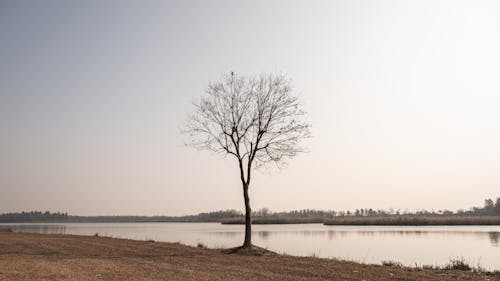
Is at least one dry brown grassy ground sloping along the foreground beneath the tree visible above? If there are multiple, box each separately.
[0,233,500,281]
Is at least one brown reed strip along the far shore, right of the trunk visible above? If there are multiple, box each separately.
[221,216,500,225]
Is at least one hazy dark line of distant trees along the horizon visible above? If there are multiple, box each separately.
[0,198,500,223]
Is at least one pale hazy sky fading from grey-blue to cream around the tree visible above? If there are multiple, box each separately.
[0,0,500,215]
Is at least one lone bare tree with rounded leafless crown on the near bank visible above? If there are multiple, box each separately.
[183,72,310,248]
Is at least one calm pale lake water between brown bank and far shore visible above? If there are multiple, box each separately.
[0,223,500,270]
